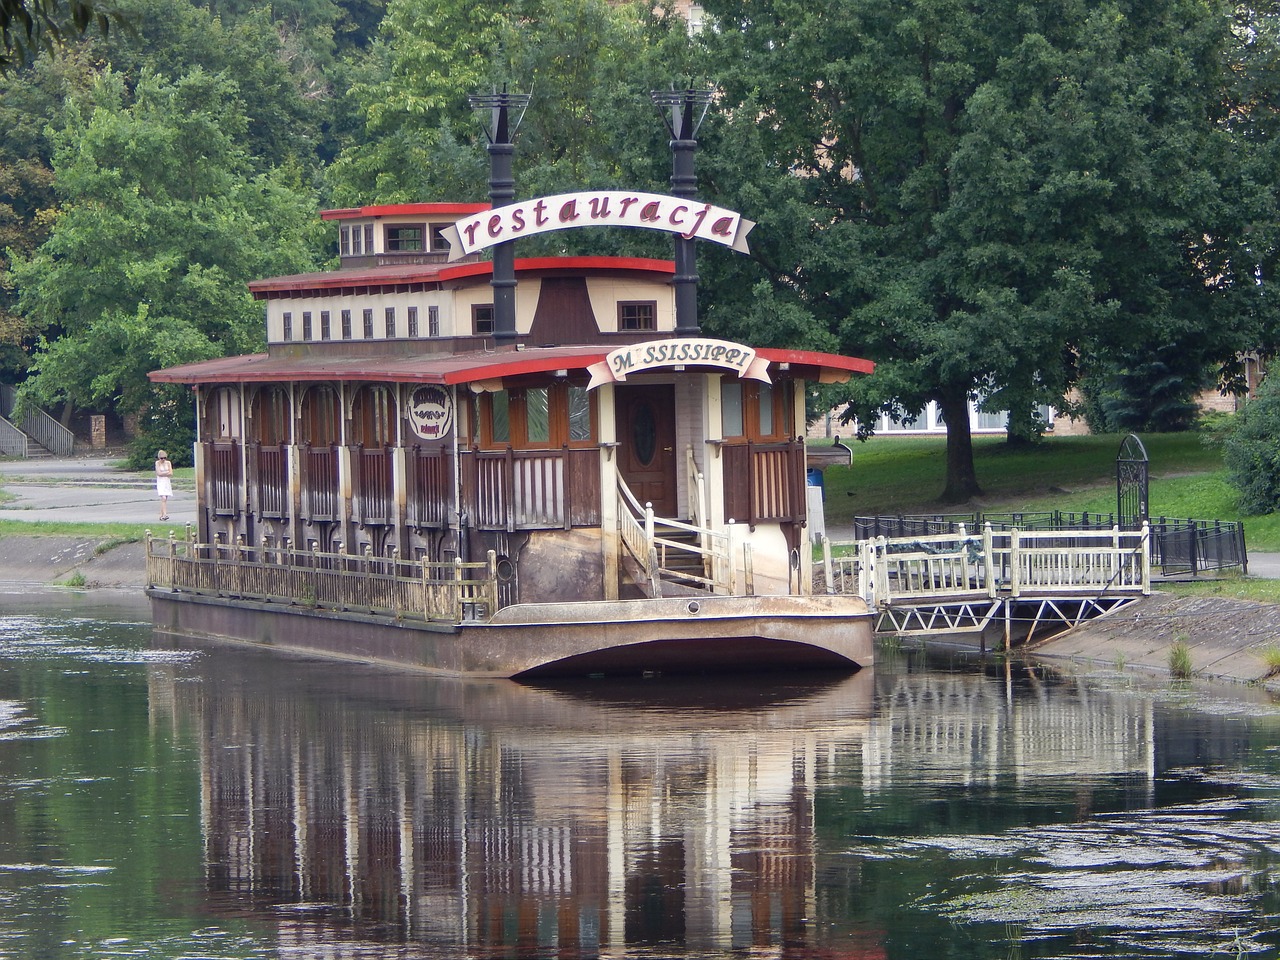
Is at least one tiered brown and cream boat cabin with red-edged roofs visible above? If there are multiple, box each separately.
[152,204,872,604]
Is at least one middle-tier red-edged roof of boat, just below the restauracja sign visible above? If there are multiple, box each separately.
[248,257,676,298]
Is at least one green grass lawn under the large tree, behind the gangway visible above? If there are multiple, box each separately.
[824,433,1280,552]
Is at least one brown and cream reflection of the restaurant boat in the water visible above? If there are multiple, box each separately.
[151,649,883,956]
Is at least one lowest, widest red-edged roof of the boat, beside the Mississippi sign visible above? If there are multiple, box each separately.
[151,344,876,384]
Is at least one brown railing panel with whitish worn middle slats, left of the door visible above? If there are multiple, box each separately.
[463,447,600,531]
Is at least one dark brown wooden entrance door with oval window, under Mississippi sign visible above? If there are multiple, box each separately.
[614,384,678,517]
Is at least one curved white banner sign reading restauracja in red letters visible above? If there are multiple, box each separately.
[444,189,755,262]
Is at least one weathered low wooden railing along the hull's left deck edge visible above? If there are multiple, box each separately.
[146,536,498,623]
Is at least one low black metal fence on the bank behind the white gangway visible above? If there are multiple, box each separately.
[854,511,1249,576]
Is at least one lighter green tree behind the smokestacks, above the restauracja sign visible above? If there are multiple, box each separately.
[330,0,690,216]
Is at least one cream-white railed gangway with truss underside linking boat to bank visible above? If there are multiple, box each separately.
[822,524,1151,646]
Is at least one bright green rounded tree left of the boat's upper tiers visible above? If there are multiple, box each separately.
[13,70,319,435]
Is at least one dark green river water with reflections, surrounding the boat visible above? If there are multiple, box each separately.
[0,593,1280,960]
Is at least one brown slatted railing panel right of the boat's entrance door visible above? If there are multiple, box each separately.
[721,440,806,530]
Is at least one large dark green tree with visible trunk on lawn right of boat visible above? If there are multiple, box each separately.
[700,0,1275,502]
